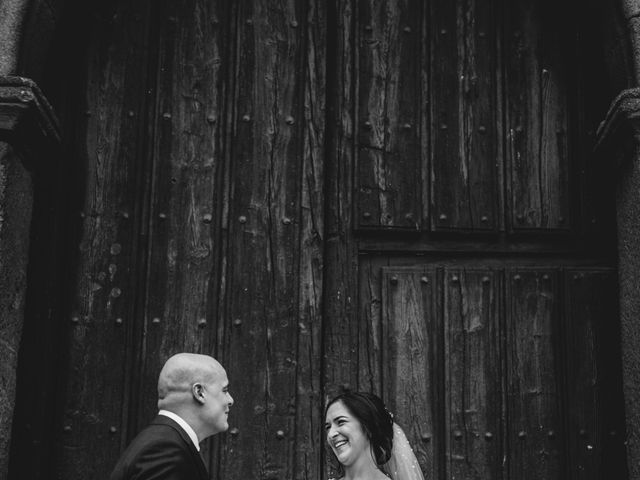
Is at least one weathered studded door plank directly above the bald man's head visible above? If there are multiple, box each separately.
[138,0,228,434]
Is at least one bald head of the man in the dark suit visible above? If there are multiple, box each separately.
[158,353,233,441]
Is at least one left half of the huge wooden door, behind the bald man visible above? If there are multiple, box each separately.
[12,0,327,479]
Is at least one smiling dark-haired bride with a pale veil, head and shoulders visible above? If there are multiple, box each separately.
[325,392,423,480]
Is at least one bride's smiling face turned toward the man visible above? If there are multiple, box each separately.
[325,401,371,467]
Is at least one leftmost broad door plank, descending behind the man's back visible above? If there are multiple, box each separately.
[56,2,148,478]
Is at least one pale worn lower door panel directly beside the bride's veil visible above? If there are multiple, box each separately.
[382,267,443,478]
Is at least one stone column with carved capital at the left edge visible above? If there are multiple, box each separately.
[0,77,60,478]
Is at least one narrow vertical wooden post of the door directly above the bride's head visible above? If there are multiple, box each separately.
[322,0,360,400]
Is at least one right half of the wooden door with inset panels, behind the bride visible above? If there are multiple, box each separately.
[324,0,626,480]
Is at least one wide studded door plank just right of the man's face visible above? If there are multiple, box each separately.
[221,1,304,479]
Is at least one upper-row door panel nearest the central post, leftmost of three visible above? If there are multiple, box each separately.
[356,0,424,230]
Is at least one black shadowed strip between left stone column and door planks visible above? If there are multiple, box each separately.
[9,1,92,480]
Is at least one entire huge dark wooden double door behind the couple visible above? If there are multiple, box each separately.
[6,0,626,480]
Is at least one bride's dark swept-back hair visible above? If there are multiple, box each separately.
[324,391,393,470]
